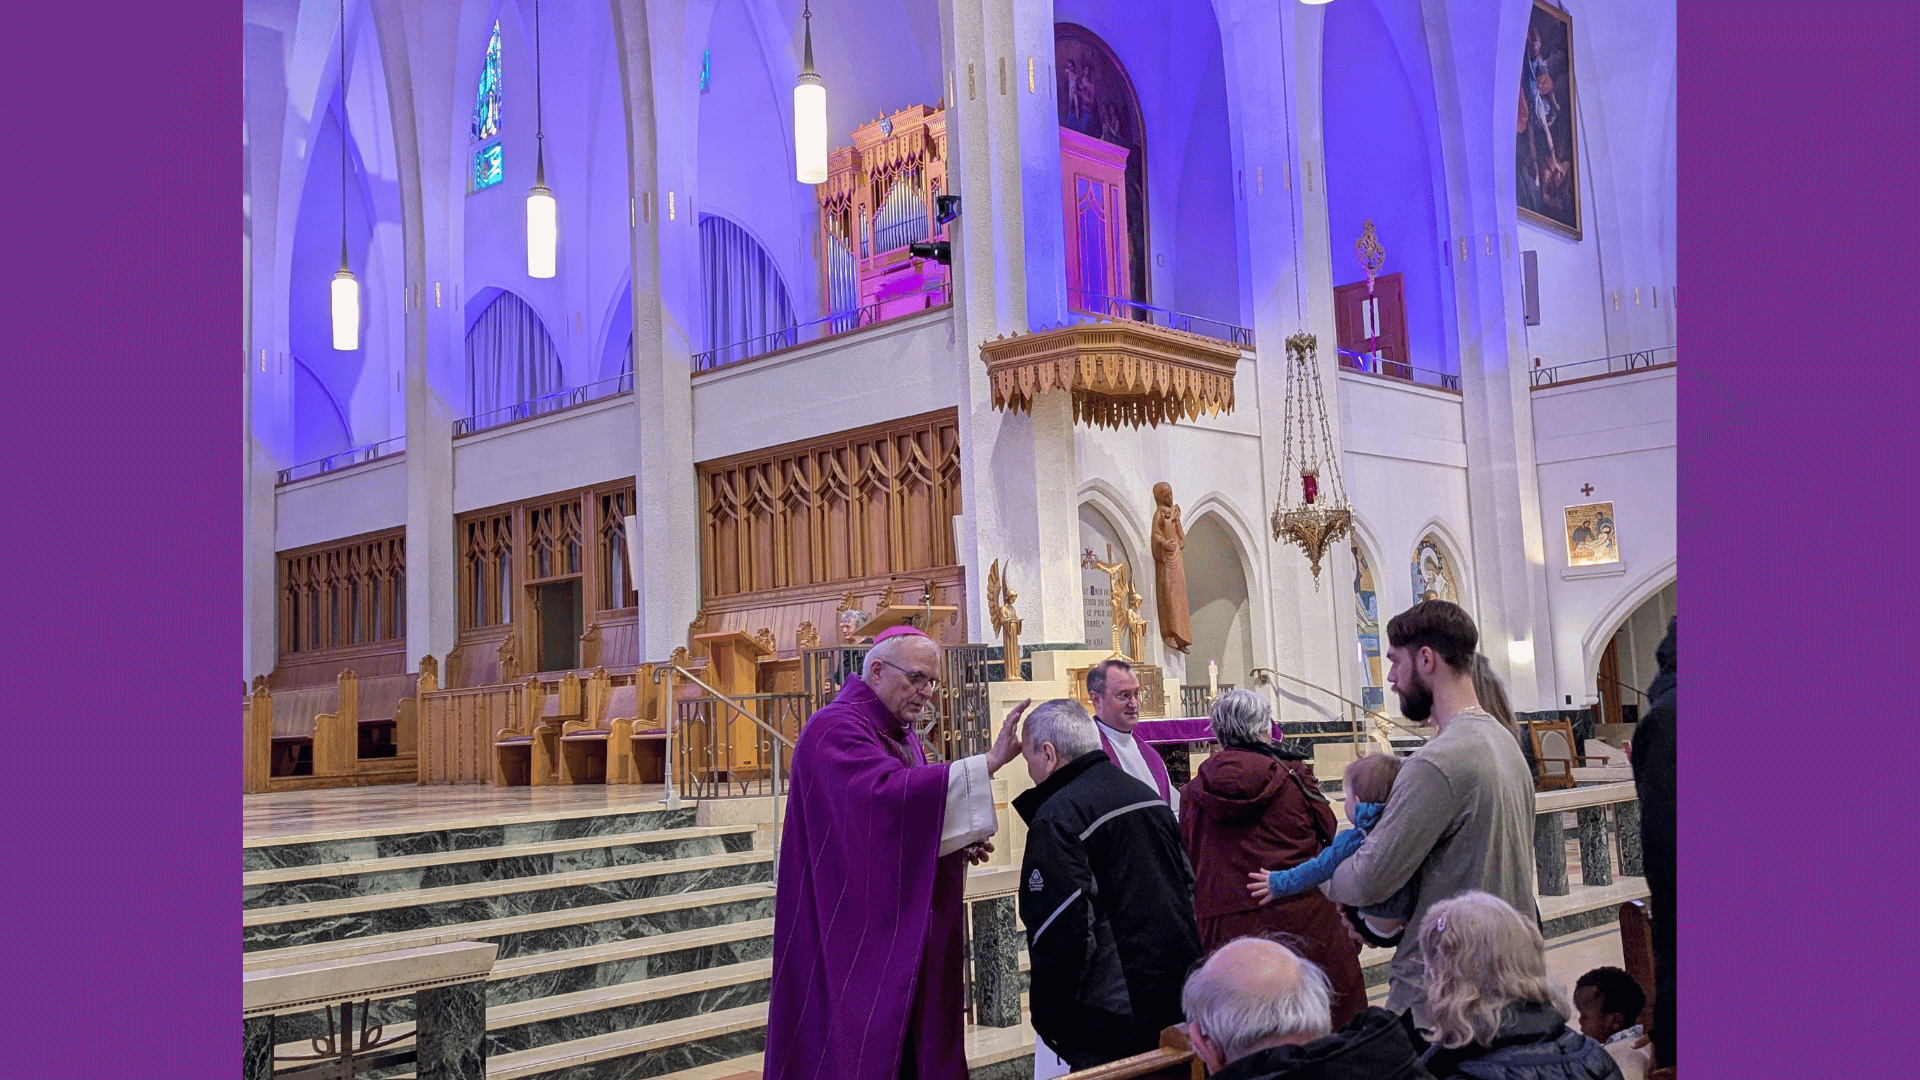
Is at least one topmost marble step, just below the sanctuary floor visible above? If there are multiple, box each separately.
[242,805,695,872]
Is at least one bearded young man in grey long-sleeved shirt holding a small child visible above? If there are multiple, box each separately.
[1321,600,1534,1026]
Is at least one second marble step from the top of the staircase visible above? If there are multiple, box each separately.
[242,824,755,909]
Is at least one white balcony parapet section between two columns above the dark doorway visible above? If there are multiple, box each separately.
[453,396,634,513]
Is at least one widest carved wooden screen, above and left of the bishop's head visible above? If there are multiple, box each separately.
[699,409,960,598]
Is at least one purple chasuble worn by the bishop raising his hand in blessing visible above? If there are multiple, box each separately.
[766,676,966,1080]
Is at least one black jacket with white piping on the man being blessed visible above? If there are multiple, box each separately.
[1014,749,1200,1068]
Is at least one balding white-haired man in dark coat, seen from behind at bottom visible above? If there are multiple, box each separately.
[1181,938,1430,1080]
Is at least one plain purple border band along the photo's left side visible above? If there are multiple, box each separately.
[0,0,242,1076]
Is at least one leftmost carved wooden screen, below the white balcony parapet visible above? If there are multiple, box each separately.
[280,528,407,653]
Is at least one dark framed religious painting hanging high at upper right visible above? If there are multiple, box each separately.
[1513,0,1580,240]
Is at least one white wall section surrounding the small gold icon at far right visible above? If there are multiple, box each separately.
[1532,369,1678,707]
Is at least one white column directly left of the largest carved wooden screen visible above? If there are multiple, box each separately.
[611,0,701,659]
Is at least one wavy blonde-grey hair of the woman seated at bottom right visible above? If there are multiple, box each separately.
[1421,890,1574,1049]
